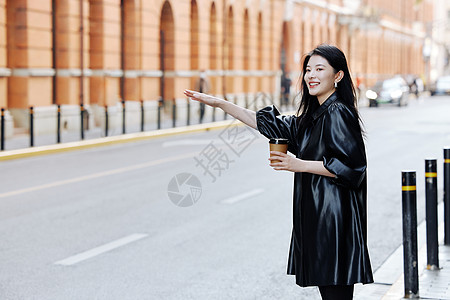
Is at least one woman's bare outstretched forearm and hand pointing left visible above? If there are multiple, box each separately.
[184,90,257,129]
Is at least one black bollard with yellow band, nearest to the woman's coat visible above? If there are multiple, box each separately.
[402,171,419,298]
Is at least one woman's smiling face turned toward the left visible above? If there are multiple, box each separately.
[303,55,343,104]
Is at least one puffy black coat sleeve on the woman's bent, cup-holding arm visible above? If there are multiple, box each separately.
[323,103,367,189]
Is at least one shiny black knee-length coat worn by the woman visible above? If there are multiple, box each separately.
[256,94,373,286]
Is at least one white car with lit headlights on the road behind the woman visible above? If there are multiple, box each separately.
[366,77,409,106]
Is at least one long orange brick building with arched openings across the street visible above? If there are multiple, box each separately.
[0,0,433,134]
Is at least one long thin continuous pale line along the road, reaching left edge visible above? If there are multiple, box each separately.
[0,151,198,198]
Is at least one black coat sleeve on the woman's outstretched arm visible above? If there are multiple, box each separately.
[256,105,298,155]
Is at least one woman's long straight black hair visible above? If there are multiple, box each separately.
[297,44,362,131]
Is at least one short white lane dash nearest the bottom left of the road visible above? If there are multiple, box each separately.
[55,233,147,266]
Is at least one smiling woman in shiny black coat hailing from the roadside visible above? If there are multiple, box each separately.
[185,45,373,300]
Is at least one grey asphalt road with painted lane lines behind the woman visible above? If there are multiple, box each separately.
[0,97,450,300]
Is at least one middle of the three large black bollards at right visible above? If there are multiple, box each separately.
[425,159,439,270]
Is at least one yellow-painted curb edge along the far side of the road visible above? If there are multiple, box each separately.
[0,119,243,161]
